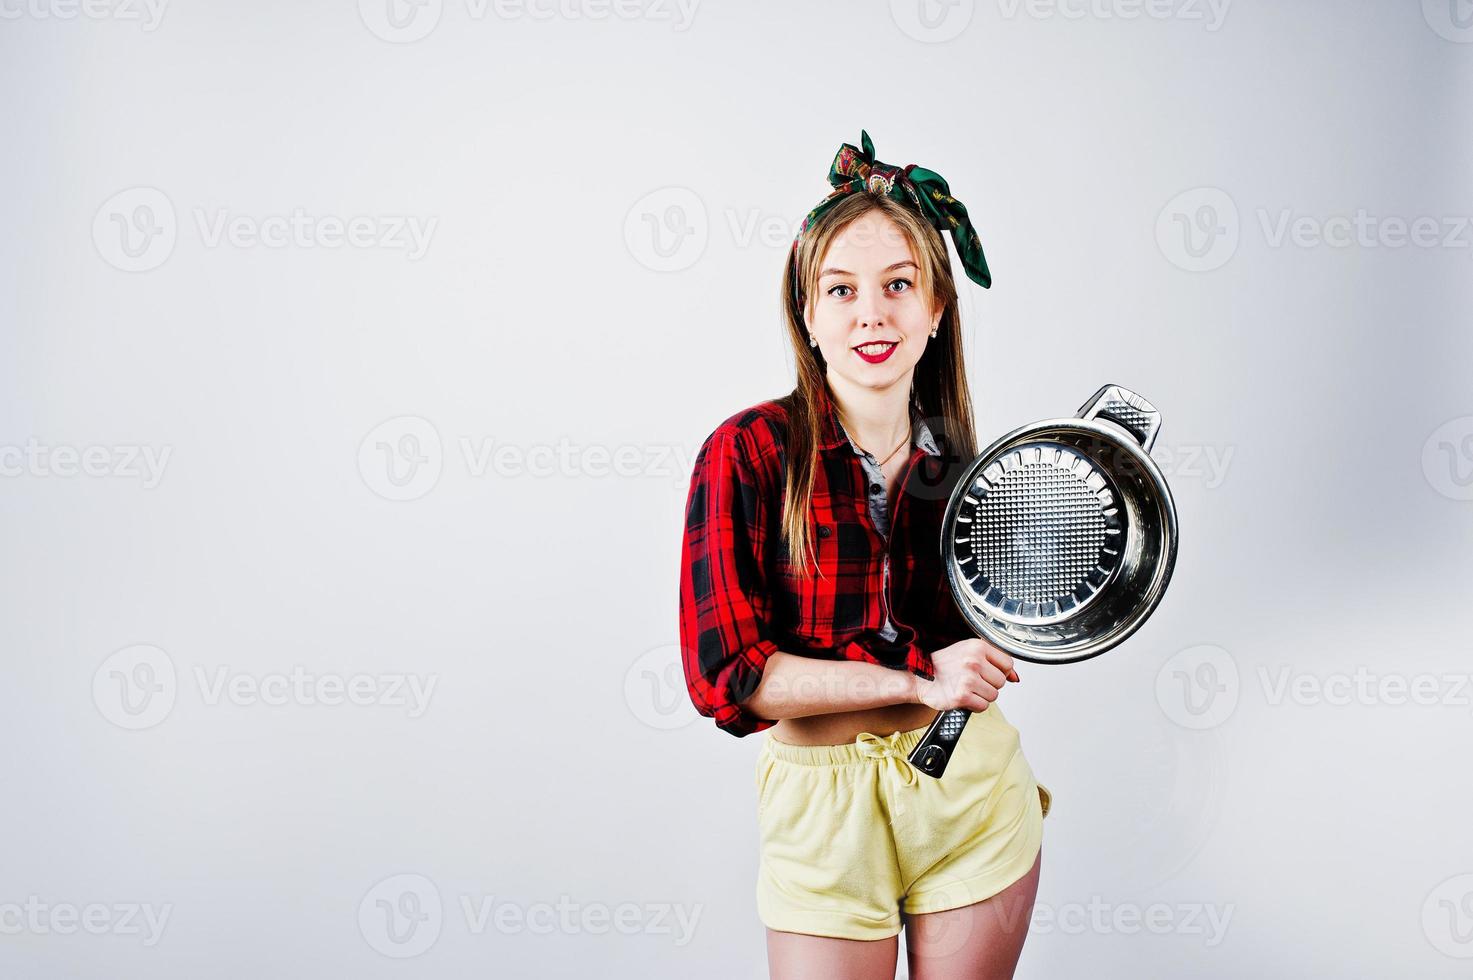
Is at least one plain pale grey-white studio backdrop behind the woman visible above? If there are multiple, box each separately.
[0,0,1473,979]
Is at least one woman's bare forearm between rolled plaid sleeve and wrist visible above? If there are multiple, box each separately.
[742,651,921,719]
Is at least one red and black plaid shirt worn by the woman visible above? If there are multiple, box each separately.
[681,392,977,737]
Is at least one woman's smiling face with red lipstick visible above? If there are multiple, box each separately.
[809,211,941,389]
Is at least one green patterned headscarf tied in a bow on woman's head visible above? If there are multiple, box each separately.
[792,130,993,305]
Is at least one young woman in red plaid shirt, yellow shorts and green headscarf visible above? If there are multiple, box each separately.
[681,134,1050,980]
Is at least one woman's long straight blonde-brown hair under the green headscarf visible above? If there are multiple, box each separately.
[776,190,977,578]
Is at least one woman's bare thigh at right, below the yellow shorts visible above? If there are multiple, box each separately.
[906,847,1043,980]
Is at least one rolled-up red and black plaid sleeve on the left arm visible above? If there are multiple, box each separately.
[681,426,778,737]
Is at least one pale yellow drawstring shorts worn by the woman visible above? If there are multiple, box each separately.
[756,701,1052,939]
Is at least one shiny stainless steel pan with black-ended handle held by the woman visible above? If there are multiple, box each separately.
[909,385,1177,777]
